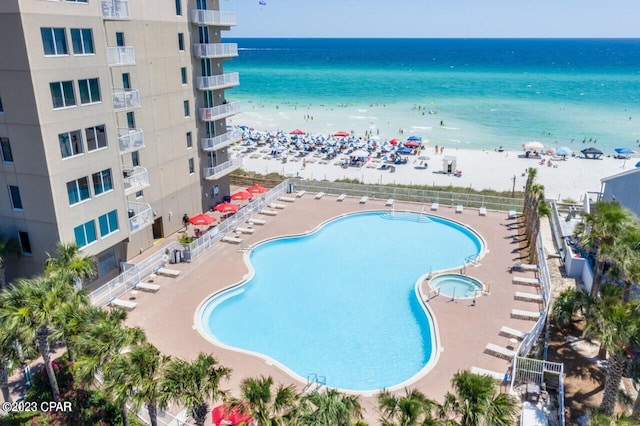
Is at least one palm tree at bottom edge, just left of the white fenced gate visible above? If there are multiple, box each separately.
[443,371,517,426]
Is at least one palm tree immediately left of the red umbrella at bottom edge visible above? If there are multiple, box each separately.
[158,353,231,426]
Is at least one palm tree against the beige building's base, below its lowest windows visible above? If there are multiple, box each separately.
[44,242,95,290]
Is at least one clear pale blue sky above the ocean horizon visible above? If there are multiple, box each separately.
[220,0,640,38]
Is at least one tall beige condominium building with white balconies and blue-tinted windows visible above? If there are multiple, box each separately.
[0,0,240,281]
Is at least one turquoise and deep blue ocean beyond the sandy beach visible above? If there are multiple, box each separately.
[224,38,640,154]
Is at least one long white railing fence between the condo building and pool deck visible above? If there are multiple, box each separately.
[89,180,290,306]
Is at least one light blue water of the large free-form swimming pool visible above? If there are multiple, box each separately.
[200,212,483,391]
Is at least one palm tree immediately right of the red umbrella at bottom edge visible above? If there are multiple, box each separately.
[240,376,297,426]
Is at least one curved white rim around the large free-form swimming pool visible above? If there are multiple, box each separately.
[194,209,488,397]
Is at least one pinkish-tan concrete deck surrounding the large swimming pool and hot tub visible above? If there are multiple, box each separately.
[122,193,542,424]
